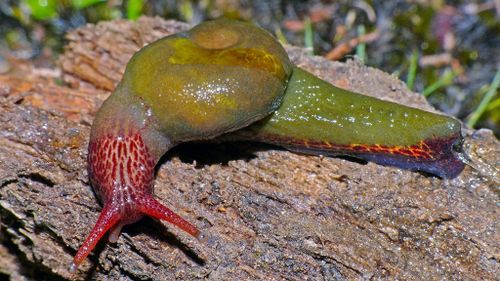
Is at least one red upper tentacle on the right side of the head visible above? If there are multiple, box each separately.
[137,195,200,237]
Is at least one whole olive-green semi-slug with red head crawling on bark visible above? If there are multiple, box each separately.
[70,19,464,271]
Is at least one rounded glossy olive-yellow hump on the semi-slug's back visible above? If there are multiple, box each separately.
[117,20,292,142]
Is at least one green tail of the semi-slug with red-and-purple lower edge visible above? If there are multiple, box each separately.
[236,68,464,178]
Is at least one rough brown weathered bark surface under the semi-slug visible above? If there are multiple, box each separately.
[0,18,500,280]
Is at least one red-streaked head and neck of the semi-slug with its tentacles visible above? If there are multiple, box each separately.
[71,130,199,271]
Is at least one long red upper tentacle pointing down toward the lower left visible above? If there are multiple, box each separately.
[69,204,120,272]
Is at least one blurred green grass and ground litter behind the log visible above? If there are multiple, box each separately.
[0,0,500,137]
